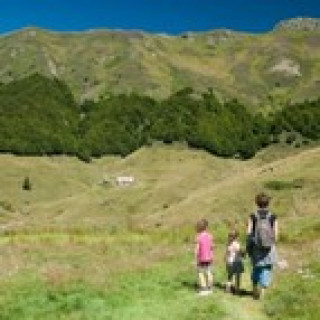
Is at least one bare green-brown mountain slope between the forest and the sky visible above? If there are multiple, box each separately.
[0,19,320,105]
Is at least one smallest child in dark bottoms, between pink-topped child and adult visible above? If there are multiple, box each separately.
[225,230,244,293]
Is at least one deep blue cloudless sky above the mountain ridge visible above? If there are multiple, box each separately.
[0,0,320,34]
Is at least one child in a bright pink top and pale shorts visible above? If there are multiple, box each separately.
[195,219,213,295]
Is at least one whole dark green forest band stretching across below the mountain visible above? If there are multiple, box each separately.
[0,74,320,161]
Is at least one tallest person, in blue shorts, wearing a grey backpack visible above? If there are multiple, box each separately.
[247,193,278,299]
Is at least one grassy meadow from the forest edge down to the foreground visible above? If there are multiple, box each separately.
[0,144,320,320]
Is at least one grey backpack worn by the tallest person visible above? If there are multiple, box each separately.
[253,212,275,249]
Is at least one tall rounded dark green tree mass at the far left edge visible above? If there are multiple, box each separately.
[0,74,79,155]
